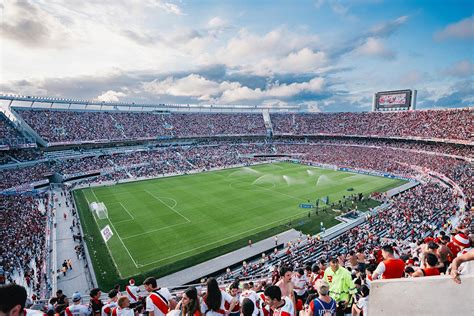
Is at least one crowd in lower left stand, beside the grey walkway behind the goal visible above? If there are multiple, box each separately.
[0,195,48,295]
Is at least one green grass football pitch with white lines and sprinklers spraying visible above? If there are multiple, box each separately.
[74,163,404,285]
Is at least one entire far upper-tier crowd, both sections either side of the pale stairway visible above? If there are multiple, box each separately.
[13,108,472,144]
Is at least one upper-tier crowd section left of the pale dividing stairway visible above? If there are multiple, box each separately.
[17,109,266,144]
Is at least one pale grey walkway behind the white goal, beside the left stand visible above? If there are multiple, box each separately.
[53,189,92,297]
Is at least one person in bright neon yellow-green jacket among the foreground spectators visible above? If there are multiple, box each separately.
[323,257,357,315]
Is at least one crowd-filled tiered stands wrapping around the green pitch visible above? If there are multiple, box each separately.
[0,103,474,315]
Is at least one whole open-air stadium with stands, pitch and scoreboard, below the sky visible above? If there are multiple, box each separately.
[0,2,474,316]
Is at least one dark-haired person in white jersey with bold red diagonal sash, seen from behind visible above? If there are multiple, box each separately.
[143,277,176,316]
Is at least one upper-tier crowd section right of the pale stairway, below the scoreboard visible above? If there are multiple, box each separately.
[270,108,472,140]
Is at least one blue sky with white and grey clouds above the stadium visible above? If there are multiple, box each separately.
[0,0,474,112]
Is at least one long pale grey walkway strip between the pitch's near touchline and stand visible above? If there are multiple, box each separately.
[157,229,300,287]
